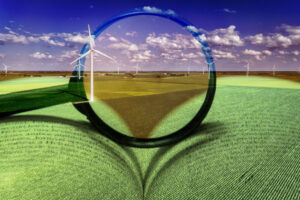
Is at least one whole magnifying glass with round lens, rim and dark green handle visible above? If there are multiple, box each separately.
[0,7,216,147]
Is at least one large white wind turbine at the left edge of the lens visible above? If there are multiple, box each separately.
[71,25,115,102]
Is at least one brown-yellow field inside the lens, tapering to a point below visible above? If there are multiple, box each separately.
[85,73,208,138]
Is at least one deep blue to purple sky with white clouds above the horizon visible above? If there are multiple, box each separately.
[0,0,300,71]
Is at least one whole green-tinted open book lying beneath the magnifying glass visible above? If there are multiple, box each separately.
[0,77,300,200]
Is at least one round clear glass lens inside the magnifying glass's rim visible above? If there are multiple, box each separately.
[84,15,209,138]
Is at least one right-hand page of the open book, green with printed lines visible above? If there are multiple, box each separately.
[144,81,300,199]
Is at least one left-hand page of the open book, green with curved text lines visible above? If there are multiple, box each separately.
[0,104,142,199]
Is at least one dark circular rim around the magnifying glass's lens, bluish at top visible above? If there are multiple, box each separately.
[70,7,216,148]
